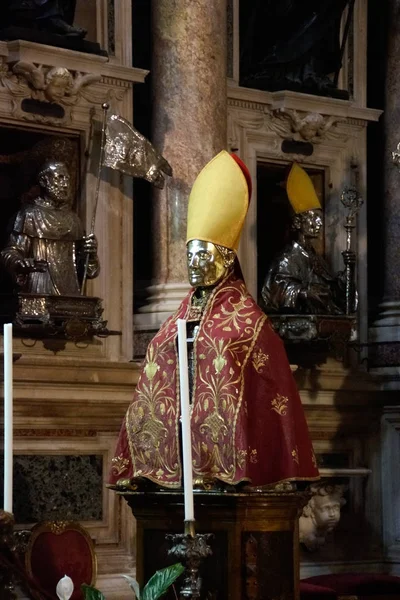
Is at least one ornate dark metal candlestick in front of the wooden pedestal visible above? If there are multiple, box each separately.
[166,521,212,600]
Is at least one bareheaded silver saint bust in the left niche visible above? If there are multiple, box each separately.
[0,160,100,296]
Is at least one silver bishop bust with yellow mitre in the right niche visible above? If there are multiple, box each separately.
[261,163,357,315]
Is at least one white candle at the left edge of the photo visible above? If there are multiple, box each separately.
[3,323,13,513]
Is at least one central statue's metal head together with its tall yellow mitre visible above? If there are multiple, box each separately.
[186,150,251,288]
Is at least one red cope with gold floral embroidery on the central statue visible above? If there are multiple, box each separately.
[110,273,318,488]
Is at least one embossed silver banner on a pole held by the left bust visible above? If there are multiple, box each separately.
[81,103,172,294]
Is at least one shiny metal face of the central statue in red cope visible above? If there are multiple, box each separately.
[186,240,227,287]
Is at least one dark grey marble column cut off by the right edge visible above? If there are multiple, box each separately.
[369,0,400,389]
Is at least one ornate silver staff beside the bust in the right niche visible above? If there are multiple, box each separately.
[340,187,364,315]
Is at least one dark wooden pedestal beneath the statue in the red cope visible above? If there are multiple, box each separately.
[124,491,307,600]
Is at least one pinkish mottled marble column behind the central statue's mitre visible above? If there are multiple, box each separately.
[137,0,227,326]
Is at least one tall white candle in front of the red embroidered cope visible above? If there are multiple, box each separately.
[178,319,194,521]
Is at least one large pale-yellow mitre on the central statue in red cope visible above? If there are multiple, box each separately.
[186,150,251,250]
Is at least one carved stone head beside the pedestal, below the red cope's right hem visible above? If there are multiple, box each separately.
[299,483,346,551]
